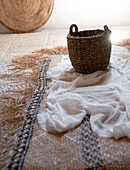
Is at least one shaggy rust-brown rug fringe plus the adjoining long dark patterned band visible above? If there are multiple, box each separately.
[0,47,67,169]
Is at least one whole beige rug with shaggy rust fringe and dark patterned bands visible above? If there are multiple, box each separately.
[0,44,130,169]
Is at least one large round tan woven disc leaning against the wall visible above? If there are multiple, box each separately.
[0,0,54,32]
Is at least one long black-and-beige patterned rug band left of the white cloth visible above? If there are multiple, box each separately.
[8,56,51,169]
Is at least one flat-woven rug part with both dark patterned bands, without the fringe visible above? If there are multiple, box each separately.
[1,46,130,170]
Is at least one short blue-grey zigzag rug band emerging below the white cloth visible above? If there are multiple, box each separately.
[81,116,103,169]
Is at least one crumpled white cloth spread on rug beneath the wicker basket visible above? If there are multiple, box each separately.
[38,46,130,139]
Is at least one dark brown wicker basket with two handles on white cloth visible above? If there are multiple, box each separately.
[67,24,111,74]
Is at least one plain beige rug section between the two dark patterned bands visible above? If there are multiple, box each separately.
[23,56,85,170]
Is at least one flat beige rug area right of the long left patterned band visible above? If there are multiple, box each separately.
[23,51,130,170]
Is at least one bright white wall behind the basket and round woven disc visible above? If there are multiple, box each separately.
[0,0,130,32]
